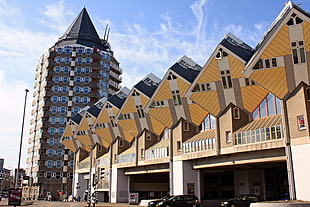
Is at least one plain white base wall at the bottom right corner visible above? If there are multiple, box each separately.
[292,144,310,201]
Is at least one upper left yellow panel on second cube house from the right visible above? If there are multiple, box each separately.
[197,58,221,83]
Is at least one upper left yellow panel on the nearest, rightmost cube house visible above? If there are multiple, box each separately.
[261,25,291,58]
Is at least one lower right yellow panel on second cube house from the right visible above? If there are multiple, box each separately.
[241,85,268,113]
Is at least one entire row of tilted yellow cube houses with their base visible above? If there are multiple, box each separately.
[63,2,310,204]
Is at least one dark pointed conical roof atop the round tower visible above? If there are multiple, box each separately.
[56,7,109,50]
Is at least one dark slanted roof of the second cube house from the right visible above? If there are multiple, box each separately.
[220,39,253,62]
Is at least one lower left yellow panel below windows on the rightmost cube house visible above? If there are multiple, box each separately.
[250,68,288,99]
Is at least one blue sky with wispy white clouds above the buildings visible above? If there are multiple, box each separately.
[0,0,310,168]
